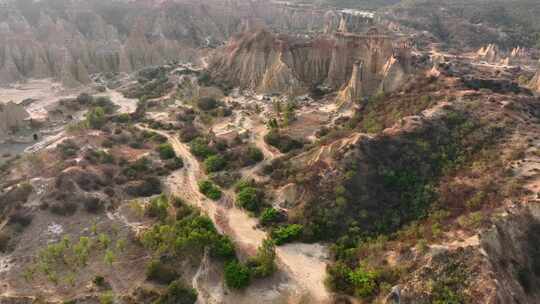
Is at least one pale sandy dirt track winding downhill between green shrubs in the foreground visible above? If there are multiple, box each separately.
[139,126,329,303]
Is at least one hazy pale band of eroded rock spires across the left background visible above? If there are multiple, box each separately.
[0,0,354,87]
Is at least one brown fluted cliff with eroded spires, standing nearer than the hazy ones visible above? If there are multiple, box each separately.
[209,30,409,97]
